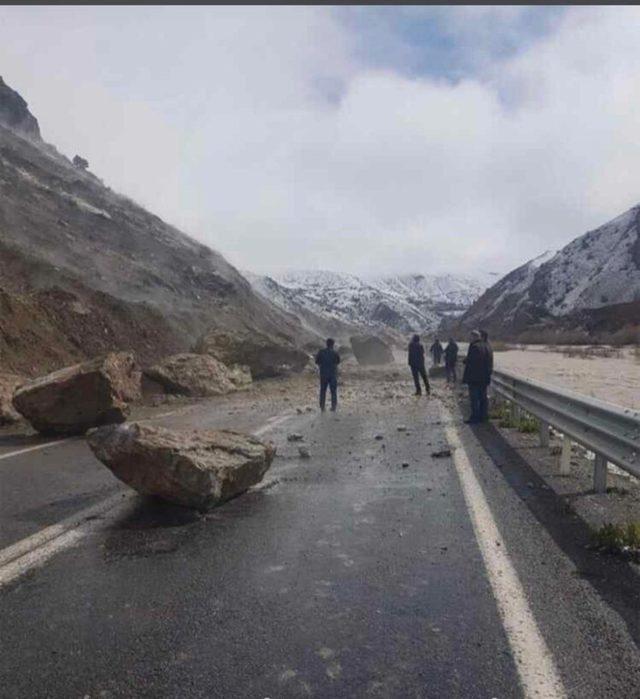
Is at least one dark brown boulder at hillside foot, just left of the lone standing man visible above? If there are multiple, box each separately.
[195,330,309,379]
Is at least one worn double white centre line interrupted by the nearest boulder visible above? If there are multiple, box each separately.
[0,413,292,588]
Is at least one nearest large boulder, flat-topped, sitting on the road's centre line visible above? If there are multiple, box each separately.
[88,422,275,510]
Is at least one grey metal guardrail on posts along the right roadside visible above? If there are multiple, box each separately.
[491,371,640,492]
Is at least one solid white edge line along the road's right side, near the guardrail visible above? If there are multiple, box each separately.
[442,407,566,699]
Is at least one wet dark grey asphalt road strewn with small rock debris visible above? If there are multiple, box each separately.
[0,382,640,699]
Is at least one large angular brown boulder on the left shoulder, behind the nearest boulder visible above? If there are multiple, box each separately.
[13,352,140,435]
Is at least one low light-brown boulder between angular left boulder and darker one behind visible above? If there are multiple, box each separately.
[145,353,251,397]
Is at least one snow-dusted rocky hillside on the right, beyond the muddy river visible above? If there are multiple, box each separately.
[460,206,640,338]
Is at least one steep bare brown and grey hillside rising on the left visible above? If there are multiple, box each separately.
[0,80,310,374]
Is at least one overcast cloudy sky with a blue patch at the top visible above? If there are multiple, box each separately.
[0,6,640,274]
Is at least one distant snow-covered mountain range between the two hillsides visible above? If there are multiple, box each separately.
[245,271,495,335]
